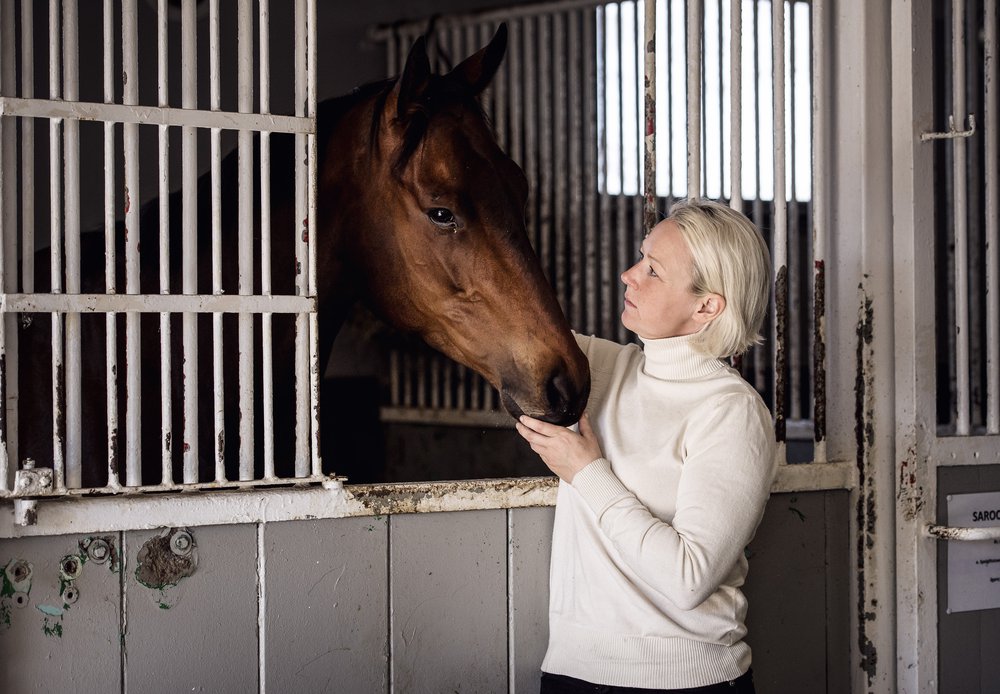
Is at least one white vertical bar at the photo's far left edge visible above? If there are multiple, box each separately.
[0,0,13,491]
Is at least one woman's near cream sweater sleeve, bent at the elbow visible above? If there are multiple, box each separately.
[572,394,775,610]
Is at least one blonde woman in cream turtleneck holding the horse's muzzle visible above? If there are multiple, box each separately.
[517,199,775,694]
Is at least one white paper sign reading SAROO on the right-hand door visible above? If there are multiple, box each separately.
[948,492,1000,613]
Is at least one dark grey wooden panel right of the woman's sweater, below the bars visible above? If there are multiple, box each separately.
[744,492,849,692]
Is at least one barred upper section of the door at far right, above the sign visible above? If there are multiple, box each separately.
[921,0,1000,436]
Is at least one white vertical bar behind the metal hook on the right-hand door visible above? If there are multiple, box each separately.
[951,0,969,436]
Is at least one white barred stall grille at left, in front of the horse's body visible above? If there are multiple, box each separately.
[0,0,322,495]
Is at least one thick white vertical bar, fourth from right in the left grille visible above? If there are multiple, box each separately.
[237,0,254,480]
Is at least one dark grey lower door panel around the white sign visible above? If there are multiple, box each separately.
[928,465,1000,693]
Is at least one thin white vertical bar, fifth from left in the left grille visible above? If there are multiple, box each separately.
[101,0,121,489]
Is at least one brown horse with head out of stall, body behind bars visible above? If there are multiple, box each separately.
[13,25,590,488]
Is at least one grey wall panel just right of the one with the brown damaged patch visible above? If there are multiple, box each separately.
[264,516,389,694]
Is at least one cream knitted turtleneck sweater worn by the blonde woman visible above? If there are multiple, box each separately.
[542,335,775,689]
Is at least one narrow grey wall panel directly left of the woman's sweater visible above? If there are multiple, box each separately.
[510,508,555,694]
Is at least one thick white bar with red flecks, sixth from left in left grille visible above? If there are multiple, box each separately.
[122,0,142,486]
